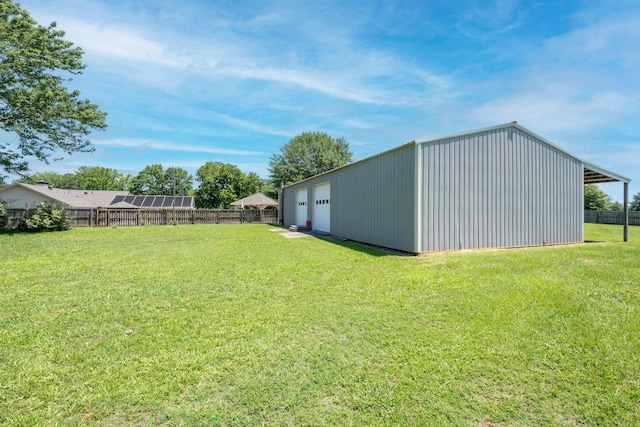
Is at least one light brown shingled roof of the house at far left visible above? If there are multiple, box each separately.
[0,183,129,208]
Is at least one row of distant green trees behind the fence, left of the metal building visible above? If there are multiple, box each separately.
[1,132,352,209]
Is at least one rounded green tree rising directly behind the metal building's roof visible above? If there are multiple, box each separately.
[269,132,353,186]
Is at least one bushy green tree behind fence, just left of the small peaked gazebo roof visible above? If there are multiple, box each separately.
[195,162,260,209]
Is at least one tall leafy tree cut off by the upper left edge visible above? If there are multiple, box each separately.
[0,0,107,175]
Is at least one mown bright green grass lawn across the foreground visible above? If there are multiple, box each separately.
[0,224,640,426]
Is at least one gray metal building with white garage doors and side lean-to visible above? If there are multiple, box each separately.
[280,122,630,253]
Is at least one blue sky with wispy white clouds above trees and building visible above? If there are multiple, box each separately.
[11,0,640,200]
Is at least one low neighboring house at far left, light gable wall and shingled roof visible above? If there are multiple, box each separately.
[0,183,129,208]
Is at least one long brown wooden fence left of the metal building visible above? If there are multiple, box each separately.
[7,208,278,228]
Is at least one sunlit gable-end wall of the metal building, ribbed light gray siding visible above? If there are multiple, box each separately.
[419,127,583,252]
